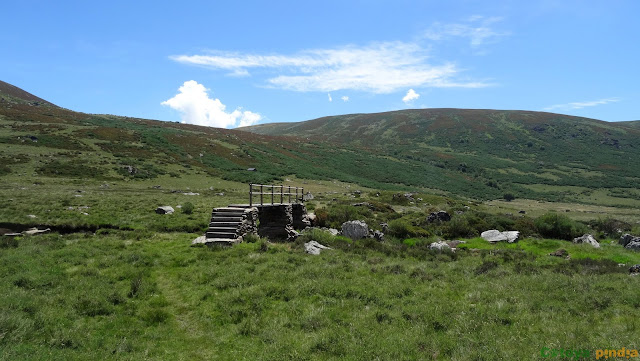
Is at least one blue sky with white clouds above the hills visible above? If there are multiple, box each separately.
[0,0,640,127]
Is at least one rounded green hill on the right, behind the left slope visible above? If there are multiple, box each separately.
[243,109,640,202]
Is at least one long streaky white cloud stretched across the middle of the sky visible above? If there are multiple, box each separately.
[171,42,490,93]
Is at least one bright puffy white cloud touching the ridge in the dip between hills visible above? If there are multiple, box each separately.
[161,80,262,128]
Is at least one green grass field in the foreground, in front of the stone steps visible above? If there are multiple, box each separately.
[0,230,640,360]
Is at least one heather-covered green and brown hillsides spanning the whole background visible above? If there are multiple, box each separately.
[0,79,640,202]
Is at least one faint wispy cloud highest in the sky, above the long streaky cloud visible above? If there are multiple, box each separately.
[424,15,509,47]
